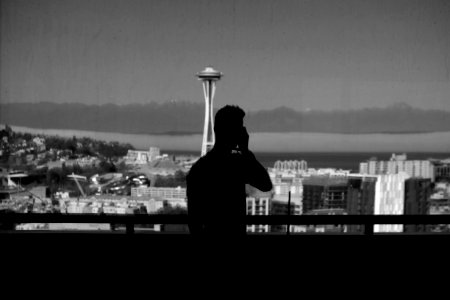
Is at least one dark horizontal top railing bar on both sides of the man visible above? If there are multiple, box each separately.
[0,213,450,225]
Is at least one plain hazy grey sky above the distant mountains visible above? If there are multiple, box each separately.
[0,0,450,110]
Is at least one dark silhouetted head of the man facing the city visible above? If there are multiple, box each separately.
[214,105,245,149]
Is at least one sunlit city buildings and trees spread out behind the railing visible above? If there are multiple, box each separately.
[0,118,450,235]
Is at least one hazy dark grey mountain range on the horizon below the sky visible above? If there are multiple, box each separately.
[0,101,450,134]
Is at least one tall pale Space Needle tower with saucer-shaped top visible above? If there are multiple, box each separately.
[196,66,223,156]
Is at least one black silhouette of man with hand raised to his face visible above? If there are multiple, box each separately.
[186,105,272,236]
